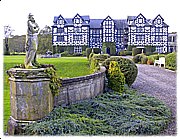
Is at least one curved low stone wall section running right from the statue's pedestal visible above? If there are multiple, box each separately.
[54,67,106,107]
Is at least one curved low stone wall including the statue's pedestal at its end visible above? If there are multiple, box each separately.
[7,67,106,135]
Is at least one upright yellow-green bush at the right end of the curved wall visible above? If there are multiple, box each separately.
[107,61,125,93]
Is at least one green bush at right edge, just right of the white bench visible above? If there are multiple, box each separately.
[165,52,177,70]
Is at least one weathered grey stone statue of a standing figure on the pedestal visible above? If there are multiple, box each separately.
[25,13,40,69]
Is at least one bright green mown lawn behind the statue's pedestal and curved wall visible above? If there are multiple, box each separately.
[4,56,90,131]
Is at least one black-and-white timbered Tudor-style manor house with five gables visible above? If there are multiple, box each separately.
[52,14,169,53]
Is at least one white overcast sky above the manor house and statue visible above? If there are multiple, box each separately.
[0,0,179,35]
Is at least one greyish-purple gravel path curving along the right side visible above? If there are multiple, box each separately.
[132,64,177,136]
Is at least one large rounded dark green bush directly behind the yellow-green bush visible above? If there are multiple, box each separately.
[102,56,138,86]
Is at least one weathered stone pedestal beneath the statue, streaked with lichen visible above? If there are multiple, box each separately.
[7,68,53,135]
